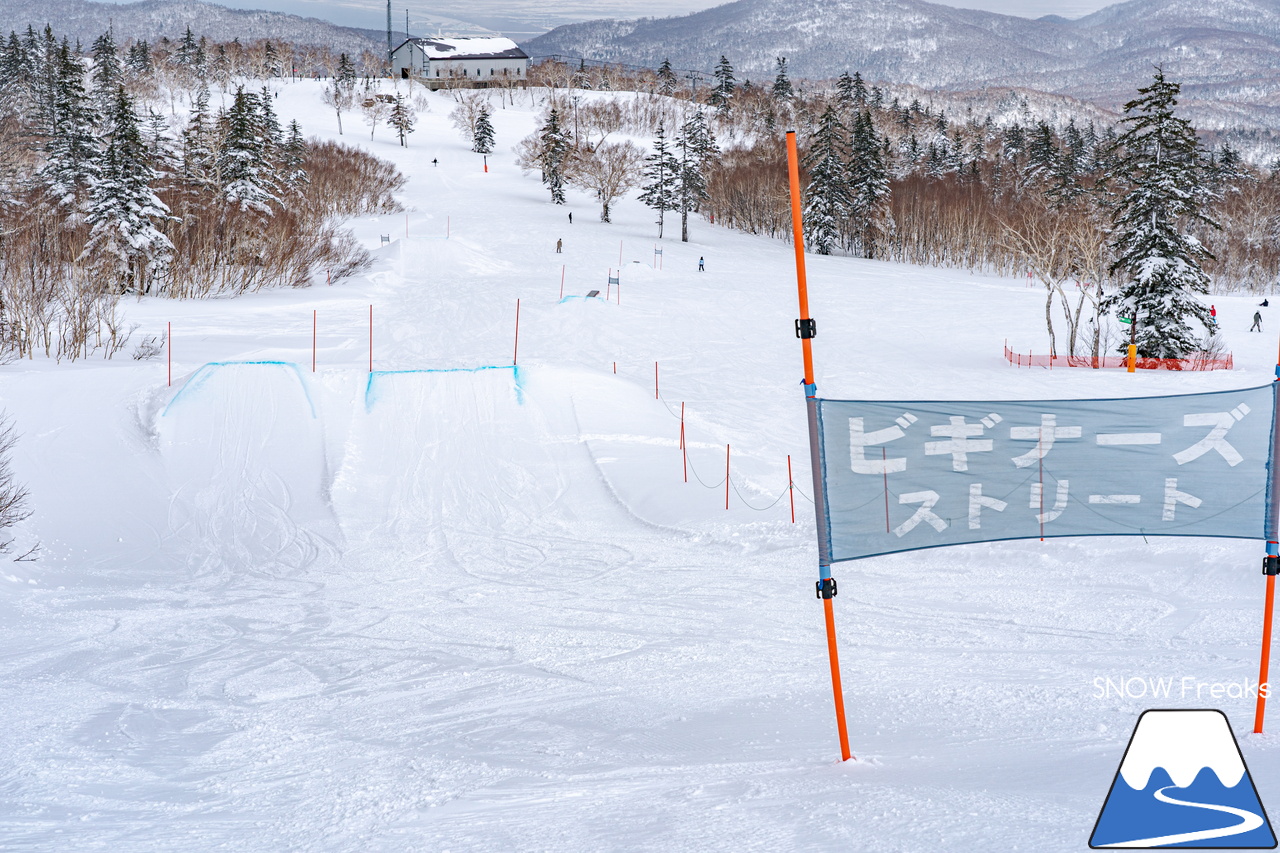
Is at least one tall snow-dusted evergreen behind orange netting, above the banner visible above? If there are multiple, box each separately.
[1106,68,1217,359]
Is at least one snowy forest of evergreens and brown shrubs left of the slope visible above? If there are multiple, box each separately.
[0,27,403,360]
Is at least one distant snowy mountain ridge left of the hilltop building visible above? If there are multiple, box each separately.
[0,0,384,54]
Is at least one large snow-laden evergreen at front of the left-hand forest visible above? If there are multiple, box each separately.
[81,86,173,295]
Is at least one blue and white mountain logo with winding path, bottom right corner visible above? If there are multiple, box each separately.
[1089,711,1276,850]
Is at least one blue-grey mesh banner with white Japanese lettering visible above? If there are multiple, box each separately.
[818,386,1275,562]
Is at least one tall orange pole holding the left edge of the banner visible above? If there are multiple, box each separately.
[787,131,852,761]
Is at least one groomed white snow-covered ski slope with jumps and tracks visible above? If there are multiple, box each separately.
[0,83,1280,853]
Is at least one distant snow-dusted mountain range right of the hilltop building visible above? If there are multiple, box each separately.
[522,0,1280,128]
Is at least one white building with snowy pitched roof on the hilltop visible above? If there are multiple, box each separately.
[392,36,529,85]
